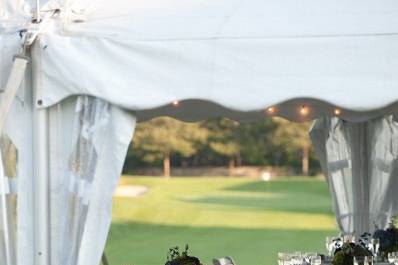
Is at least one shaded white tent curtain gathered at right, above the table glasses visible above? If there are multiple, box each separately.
[310,115,398,234]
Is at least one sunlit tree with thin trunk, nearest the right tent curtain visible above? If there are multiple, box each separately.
[274,118,311,176]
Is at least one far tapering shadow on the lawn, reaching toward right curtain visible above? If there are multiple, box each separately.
[178,181,333,216]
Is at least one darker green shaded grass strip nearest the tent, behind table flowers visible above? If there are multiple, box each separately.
[106,222,336,265]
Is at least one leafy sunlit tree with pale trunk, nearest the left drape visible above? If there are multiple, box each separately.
[133,117,207,177]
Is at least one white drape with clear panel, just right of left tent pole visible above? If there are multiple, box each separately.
[49,96,135,265]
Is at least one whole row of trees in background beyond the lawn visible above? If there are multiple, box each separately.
[125,117,319,177]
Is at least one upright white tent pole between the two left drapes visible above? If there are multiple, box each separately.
[31,45,50,265]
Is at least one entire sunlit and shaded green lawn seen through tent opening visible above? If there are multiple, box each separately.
[106,177,337,265]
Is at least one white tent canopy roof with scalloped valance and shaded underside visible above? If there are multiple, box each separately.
[0,0,398,121]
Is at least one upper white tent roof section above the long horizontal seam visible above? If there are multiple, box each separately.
[69,0,398,40]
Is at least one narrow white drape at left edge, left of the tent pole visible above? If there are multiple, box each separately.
[0,60,34,265]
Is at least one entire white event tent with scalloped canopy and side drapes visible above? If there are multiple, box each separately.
[0,0,398,265]
